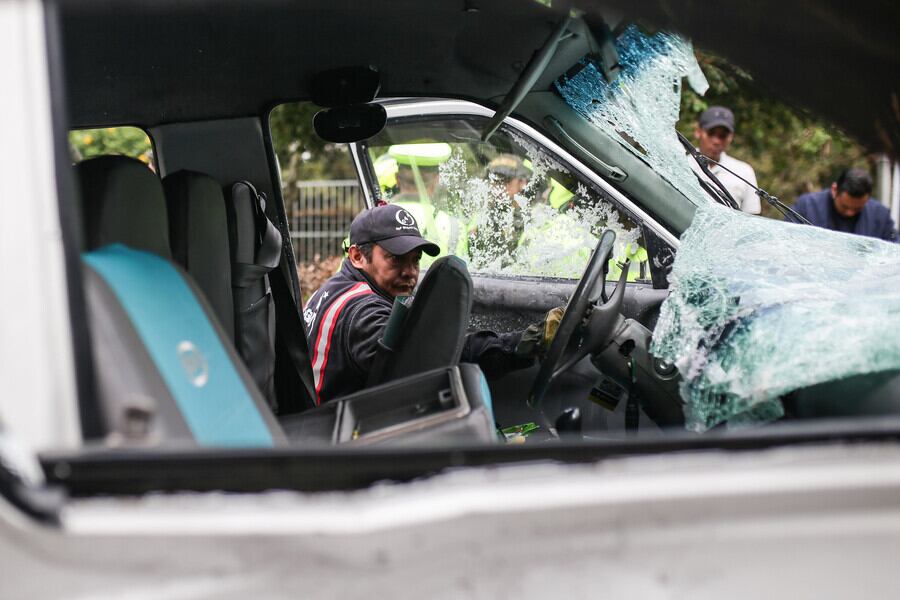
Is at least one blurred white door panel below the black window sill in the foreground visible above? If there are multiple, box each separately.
[0,444,900,599]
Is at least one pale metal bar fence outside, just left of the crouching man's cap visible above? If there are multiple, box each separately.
[284,179,365,262]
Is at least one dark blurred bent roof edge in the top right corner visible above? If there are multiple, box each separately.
[592,0,900,156]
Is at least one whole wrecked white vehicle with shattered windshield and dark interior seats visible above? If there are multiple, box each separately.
[0,0,900,598]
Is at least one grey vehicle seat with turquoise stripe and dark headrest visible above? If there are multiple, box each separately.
[76,156,284,446]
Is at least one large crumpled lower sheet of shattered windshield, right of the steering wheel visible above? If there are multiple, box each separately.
[651,204,900,431]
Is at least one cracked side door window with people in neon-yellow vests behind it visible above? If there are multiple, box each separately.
[368,116,650,281]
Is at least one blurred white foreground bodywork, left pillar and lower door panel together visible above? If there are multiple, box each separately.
[0,0,900,599]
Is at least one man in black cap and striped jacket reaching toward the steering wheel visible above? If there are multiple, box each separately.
[303,204,562,404]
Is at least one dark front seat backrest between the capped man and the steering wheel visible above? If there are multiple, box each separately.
[368,255,473,385]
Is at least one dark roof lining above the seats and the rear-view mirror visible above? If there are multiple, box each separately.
[61,0,564,127]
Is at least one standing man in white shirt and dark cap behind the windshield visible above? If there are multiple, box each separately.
[692,106,760,215]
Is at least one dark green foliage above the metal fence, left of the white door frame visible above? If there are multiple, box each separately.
[269,102,356,199]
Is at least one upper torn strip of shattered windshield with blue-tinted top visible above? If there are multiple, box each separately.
[556,25,709,205]
